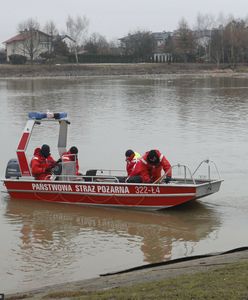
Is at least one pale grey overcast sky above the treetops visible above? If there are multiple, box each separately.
[0,0,248,46]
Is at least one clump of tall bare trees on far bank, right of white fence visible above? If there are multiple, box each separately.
[170,14,248,65]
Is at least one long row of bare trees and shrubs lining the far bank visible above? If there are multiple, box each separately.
[0,14,248,65]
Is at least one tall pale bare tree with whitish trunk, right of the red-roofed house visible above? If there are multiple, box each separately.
[66,16,89,63]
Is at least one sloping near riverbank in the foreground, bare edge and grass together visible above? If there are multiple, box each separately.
[5,248,248,300]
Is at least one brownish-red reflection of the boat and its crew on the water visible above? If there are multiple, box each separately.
[5,200,217,263]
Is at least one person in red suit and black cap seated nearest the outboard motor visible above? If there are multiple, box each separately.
[31,144,56,180]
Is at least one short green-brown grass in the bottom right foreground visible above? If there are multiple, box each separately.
[40,261,248,300]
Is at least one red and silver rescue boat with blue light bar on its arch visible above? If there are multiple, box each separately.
[3,112,223,210]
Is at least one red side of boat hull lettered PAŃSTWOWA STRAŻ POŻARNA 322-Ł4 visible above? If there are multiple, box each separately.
[4,180,196,210]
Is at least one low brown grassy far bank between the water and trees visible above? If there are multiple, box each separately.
[0,63,248,78]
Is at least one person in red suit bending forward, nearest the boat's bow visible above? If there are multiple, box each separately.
[127,150,172,183]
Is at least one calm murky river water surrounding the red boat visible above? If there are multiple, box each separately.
[0,75,248,292]
